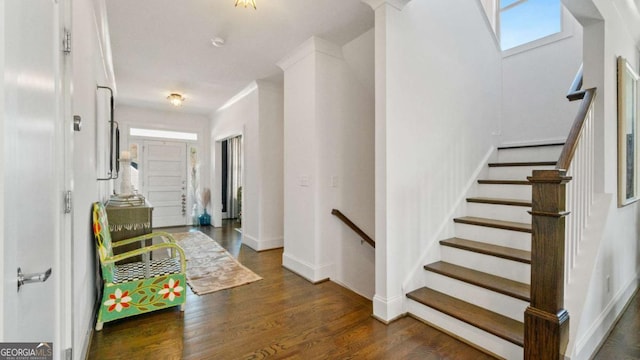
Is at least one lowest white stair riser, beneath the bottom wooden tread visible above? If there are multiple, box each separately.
[407,299,524,360]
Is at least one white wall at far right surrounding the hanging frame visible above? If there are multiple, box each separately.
[568,0,640,359]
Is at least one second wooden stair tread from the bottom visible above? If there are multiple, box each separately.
[424,261,531,302]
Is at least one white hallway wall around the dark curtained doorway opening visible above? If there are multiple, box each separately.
[210,81,283,250]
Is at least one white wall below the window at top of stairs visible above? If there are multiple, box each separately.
[501,14,582,144]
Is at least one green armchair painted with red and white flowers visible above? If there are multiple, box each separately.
[93,202,186,331]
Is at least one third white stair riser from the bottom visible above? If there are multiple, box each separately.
[440,246,531,284]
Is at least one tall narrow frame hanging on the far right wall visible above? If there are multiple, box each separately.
[618,57,639,207]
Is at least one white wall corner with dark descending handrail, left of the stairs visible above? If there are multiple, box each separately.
[280,31,375,298]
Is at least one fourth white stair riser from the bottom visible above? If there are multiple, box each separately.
[455,224,531,251]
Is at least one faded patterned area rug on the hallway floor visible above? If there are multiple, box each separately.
[172,231,262,295]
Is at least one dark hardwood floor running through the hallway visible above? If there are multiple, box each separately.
[88,222,640,360]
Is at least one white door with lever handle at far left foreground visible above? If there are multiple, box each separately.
[0,0,72,352]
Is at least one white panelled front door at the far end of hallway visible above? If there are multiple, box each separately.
[142,141,188,227]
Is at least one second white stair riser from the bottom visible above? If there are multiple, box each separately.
[426,271,529,322]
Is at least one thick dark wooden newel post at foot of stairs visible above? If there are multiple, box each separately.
[524,170,571,360]
